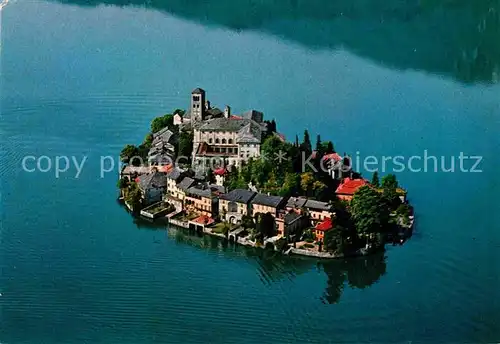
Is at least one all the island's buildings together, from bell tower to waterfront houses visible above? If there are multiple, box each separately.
[120,88,406,245]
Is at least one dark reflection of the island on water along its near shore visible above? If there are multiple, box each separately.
[134,219,386,304]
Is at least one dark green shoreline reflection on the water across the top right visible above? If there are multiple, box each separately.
[50,0,500,83]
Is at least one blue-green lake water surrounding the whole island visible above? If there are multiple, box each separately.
[0,0,500,344]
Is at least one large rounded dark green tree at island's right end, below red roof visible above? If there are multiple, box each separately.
[351,186,389,240]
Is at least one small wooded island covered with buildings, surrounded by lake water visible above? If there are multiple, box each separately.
[118,88,415,258]
